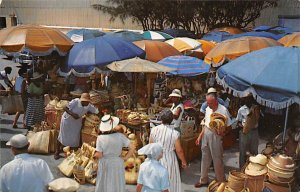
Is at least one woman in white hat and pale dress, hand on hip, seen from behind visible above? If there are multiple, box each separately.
[94,115,135,192]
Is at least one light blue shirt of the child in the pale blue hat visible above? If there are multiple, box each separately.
[137,159,170,192]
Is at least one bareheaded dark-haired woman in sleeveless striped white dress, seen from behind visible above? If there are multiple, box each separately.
[149,110,187,192]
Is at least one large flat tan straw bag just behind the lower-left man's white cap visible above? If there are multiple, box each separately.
[27,130,50,154]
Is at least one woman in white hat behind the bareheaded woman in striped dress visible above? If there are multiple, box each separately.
[164,89,184,133]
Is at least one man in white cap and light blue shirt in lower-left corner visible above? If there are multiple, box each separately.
[0,134,54,192]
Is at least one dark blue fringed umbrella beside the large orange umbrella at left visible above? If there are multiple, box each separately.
[62,36,145,73]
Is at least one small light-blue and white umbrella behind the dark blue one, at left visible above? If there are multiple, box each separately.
[67,29,105,43]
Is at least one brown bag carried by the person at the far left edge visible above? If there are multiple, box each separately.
[1,95,24,114]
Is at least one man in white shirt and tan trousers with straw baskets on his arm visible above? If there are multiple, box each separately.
[195,93,231,188]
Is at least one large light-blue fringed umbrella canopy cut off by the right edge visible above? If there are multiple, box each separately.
[217,47,300,109]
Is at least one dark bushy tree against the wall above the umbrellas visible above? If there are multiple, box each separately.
[92,0,278,34]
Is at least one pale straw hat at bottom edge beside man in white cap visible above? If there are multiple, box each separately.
[48,177,80,192]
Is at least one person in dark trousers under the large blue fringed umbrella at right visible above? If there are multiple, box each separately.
[236,96,260,168]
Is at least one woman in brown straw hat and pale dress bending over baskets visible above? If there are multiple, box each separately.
[54,93,99,159]
